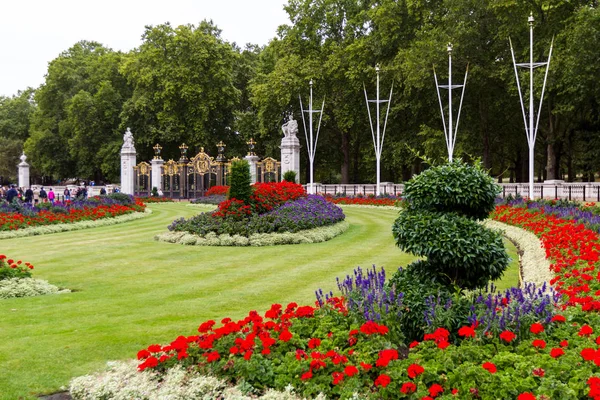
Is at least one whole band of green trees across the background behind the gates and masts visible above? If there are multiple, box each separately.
[8,0,600,183]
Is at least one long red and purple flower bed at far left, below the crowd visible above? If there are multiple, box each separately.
[0,195,145,231]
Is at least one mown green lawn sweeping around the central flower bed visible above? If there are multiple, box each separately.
[0,203,516,399]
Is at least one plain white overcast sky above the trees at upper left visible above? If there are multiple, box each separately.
[0,0,289,96]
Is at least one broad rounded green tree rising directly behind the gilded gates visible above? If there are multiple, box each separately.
[121,21,243,158]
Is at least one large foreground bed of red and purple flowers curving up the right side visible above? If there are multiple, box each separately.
[83,202,600,400]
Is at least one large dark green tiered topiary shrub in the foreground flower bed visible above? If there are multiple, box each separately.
[392,161,509,289]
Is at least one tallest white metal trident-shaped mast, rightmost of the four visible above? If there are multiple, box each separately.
[508,13,554,199]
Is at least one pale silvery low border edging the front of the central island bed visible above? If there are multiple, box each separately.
[154,221,350,247]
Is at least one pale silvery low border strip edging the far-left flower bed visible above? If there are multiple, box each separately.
[0,207,152,240]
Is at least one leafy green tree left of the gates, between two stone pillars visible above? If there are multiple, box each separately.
[25,41,131,181]
